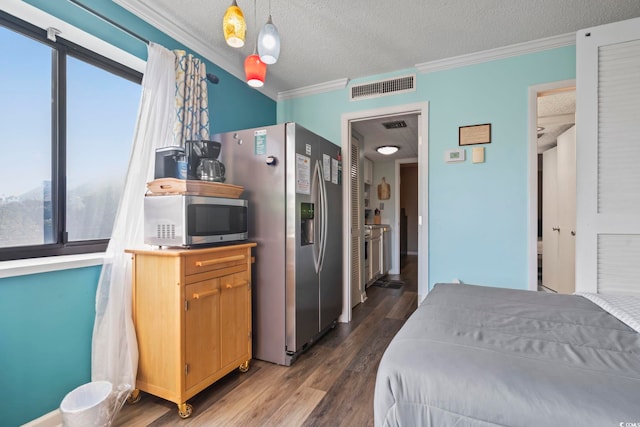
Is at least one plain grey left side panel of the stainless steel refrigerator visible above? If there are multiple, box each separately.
[218,125,289,365]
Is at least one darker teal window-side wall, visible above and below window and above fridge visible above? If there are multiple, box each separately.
[0,0,276,426]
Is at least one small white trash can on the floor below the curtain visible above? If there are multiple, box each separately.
[60,381,131,427]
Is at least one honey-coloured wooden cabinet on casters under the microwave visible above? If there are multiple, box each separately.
[127,243,256,418]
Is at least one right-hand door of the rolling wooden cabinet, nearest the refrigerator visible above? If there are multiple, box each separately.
[220,271,251,367]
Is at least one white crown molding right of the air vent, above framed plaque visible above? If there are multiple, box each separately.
[416,33,576,73]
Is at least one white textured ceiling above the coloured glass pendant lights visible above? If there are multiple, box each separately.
[113,0,640,96]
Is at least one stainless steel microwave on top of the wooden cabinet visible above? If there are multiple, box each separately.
[144,194,249,248]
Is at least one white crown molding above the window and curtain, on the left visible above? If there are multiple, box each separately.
[113,0,277,100]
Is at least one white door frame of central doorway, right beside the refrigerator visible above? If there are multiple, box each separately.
[338,102,429,323]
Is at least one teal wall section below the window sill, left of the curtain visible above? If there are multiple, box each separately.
[0,267,100,426]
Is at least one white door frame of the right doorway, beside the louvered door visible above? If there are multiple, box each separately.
[528,79,576,291]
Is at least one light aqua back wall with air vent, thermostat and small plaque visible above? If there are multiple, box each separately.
[278,46,576,289]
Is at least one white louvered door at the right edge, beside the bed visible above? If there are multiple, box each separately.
[576,18,640,295]
